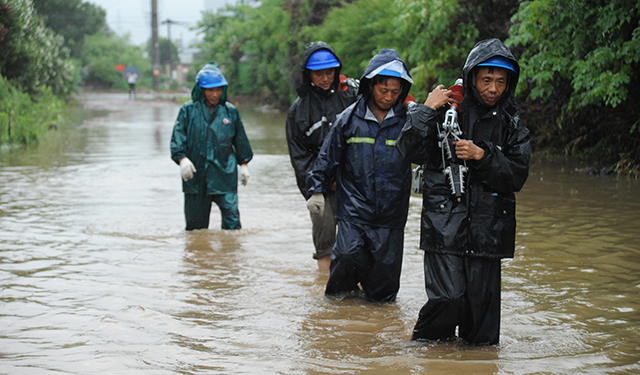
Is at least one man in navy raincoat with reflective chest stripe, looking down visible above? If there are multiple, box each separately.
[307,49,413,303]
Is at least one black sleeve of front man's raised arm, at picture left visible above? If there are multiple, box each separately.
[396,104,438,164]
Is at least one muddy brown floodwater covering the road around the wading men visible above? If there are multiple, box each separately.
[0,94,640,374]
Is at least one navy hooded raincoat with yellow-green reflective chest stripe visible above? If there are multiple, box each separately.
[307,49,411,228]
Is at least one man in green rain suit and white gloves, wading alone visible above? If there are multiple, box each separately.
[171,62,253,230]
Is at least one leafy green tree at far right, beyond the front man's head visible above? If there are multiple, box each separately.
[507,0,640,168]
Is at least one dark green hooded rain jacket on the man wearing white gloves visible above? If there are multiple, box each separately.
[171,62,253,195]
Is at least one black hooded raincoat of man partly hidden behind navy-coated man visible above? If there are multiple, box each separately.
[286,42,356,196]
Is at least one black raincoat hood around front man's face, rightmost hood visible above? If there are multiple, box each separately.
[462,38,520,110]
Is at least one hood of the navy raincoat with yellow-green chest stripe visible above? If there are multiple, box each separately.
[358,48,413,103]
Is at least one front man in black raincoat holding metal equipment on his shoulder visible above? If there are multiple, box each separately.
[396,39,531,345]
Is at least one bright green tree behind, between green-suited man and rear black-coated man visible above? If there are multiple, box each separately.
[198,0,350,107]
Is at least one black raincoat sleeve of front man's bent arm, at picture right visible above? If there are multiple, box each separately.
[468,116,531,193]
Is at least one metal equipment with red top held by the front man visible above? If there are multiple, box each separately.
[438,79,469,202]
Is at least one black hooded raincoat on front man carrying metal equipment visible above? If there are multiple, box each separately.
[396,39,531,258]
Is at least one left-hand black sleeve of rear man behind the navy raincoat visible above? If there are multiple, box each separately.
[286,98,315,195]
